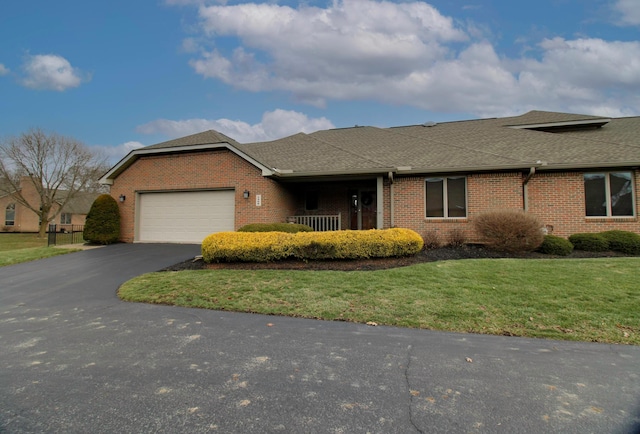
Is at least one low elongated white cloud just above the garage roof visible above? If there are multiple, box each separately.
[136,109,334,143]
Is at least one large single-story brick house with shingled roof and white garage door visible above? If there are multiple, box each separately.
[100,111,640,242]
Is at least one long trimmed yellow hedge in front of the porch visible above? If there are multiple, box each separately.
[202,228,423,262]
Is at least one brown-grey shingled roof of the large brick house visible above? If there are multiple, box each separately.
[103,111,640,181]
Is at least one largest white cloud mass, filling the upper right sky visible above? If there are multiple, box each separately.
[172,0,640,116]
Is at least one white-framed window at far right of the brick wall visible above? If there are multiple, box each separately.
[584,172,634,217]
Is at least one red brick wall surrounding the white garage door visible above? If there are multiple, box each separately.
[111,150,294,242]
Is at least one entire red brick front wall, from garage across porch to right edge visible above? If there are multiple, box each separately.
[111,150,640,242]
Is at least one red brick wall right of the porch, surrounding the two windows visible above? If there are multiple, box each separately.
[385,171,640,241]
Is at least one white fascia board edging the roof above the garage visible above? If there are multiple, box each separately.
[98,143,273,185]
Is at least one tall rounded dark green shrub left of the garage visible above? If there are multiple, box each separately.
[83,194,120,244]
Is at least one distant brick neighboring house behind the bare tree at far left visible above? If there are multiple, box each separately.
[0,177,98,232]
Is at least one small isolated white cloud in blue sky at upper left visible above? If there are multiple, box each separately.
[22,54,90,92]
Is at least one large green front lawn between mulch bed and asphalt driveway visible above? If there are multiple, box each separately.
[119,258,640,345]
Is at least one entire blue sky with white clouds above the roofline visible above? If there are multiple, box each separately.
[0,0,640,161]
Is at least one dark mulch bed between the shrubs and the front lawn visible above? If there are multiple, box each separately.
[162,245,627,271]
